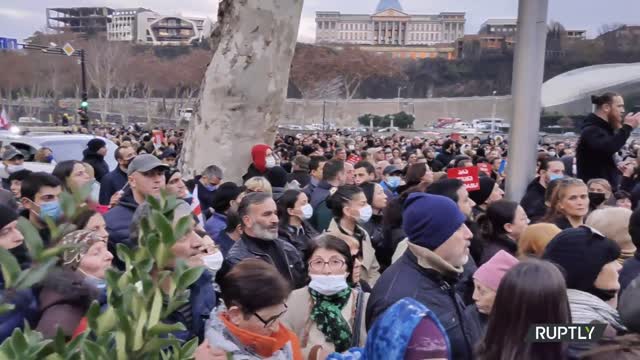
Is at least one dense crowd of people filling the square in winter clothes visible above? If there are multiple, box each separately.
[0,93,640,360]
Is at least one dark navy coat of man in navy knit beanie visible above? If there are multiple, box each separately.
[366,251,479,360]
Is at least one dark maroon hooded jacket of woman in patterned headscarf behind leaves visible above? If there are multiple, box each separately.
[36,269,100,338]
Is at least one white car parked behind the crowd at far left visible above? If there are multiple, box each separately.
[0,131,118,170]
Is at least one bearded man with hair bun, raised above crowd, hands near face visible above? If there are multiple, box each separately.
[576,92,640,189]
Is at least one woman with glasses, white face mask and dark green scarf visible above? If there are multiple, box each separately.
[283,233,369,360]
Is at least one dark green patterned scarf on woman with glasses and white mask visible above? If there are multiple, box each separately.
[309,288,352,352]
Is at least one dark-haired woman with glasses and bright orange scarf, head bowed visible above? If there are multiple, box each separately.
[205,259,303,360]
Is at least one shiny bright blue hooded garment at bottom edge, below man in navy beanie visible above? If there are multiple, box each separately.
[327,298,451,360]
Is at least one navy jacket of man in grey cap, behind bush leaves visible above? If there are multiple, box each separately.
[104,189,138,268]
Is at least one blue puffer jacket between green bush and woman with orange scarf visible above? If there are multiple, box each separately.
[166,270,218,343]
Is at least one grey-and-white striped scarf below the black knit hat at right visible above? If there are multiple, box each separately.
[567,289,627,331]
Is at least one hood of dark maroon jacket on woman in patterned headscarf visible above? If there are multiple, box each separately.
[40,268,100,309]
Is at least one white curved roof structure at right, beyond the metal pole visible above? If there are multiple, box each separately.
[542,63,640,108]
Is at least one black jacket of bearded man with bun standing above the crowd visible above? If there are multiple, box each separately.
[576,113,633,189]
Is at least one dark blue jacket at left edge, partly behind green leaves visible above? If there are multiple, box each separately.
[0,273,39,344]
